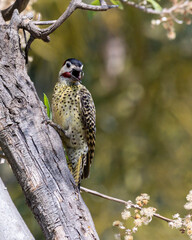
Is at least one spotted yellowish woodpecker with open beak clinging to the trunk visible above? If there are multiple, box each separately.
[52,58,96,186]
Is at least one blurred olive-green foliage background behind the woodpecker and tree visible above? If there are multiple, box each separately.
[0,0,192,240]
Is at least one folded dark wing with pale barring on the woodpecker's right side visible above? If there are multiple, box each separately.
[79,88,96,178]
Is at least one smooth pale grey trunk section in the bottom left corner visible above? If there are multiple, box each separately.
[0,178,35,240]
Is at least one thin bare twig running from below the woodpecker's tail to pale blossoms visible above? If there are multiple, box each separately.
[80,187,173,222]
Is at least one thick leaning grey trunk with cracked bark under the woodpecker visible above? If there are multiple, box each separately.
[0,11,99,240]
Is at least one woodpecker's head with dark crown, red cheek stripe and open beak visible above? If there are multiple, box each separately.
[59,58,84,83]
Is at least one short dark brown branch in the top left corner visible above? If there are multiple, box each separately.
[1,0,29,21]
